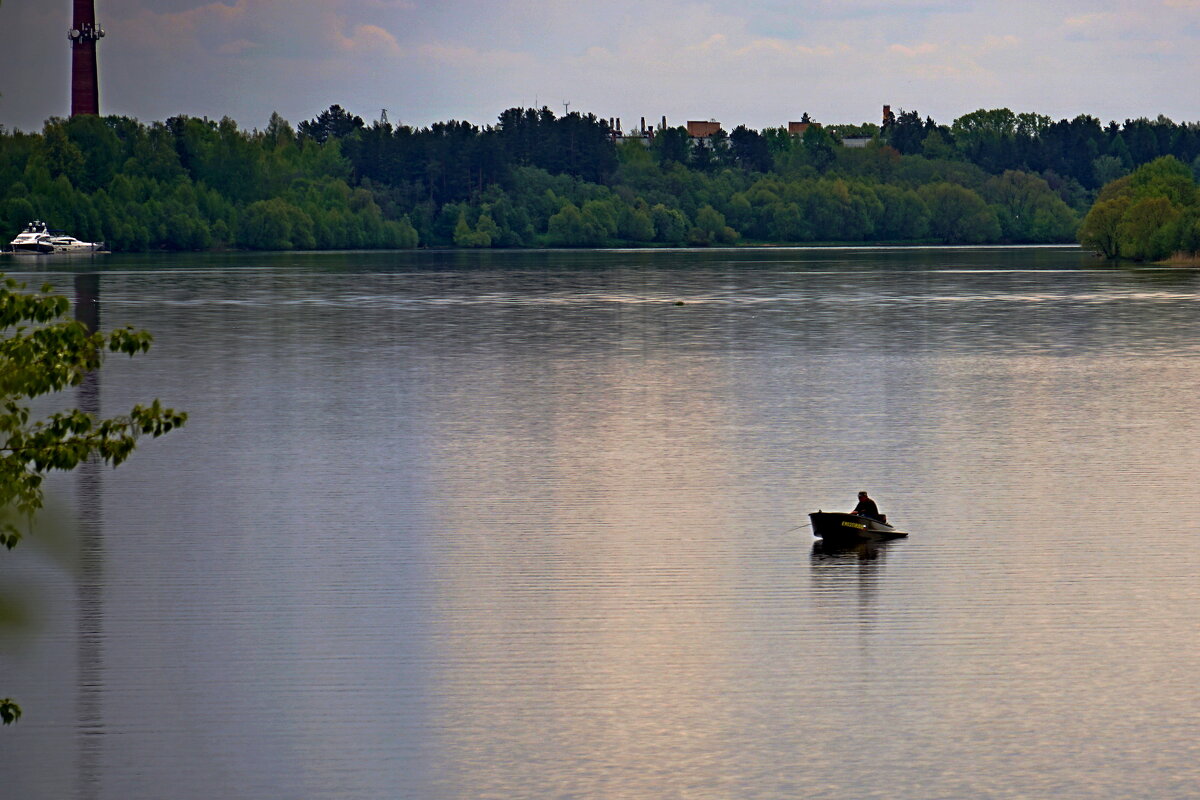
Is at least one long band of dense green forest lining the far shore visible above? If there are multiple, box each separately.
[0,106,1200,258]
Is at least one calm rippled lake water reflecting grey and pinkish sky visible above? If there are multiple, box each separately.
[0,248,1200,800]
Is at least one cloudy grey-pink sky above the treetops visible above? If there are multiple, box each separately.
[0,0,1200,130]
